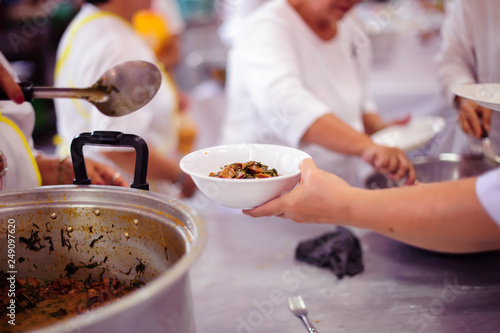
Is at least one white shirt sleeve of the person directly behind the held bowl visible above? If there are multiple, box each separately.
[235,22,329,146]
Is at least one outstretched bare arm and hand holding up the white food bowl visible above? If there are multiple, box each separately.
[244,158,500,253]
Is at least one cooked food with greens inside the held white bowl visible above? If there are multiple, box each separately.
[209,161,279,179]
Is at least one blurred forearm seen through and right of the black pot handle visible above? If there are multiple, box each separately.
[102,150,180,182]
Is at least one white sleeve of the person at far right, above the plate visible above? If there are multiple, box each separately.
[436,1,476,105]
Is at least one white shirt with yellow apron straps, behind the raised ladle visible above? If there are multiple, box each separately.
[55,4,178,191]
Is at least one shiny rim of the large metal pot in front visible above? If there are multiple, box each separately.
[0,185,207,333]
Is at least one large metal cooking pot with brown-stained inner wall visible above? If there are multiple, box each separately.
[0,133,206,333]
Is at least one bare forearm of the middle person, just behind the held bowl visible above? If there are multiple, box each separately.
[302,114,373,156]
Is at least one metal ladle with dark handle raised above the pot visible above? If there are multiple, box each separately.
[0,61,162,117]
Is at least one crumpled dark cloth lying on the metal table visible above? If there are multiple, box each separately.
[295,227,364,279]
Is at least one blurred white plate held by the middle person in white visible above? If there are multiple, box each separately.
[372,116,445,150]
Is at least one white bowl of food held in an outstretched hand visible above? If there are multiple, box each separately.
[180,144,310,209]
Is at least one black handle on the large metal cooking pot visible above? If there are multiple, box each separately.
[71,131,149,190]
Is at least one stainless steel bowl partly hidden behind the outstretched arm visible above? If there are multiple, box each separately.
[365,154,500,189]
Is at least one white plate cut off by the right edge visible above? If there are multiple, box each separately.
[453,83,500,111]
